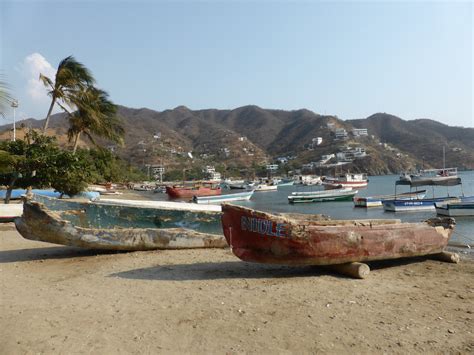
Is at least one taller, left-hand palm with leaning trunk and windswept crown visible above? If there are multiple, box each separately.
[40,56,95,132]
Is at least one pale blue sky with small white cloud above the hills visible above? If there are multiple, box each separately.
[0,0,474,127]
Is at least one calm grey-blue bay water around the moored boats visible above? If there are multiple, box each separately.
[154,171,474,251]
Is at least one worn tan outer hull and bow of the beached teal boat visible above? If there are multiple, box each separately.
[15,201,227,251]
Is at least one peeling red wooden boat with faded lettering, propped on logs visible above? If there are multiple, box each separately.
[222,204,455,265]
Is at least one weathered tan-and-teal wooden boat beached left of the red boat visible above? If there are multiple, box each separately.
[15,196,226,250]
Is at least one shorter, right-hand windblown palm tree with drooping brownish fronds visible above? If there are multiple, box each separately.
[68,86,124,153]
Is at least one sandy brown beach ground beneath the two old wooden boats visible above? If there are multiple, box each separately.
[0,224,474,354]
